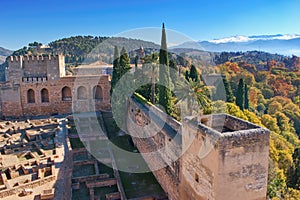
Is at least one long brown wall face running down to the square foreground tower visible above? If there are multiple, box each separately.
[127,100,181,199]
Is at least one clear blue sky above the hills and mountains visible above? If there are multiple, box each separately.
[0,0,300,49]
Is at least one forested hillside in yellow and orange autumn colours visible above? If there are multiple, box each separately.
[205,55,300,200]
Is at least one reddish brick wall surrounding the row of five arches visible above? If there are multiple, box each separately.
[21,76,110,116]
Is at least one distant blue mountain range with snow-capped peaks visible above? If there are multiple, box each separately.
[171,34,300,56]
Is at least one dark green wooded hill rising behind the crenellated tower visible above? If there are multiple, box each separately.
[13,36,159,66]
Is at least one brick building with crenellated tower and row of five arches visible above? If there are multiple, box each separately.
[0,55,110,117]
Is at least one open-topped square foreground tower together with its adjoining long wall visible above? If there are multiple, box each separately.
[127,98,270,200]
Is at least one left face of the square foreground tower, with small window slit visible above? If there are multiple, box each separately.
[180,120,219,200]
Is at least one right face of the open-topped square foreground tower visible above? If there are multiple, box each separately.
[217,128,269,200]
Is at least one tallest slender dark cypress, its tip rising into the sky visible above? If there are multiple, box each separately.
[159,24,172,114]
